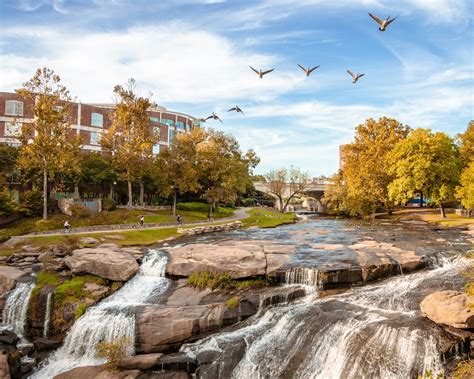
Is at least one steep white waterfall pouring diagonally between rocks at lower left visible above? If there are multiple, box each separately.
[31,251,169,378]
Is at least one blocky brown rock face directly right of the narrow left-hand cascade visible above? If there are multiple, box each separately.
[136,304,239,353]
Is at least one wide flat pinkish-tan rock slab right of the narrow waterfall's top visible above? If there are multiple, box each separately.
[166,244,267,278]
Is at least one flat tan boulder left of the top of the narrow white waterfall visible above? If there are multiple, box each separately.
[65,245,139,281]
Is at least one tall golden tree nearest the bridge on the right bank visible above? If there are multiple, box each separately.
[339,117,409,216]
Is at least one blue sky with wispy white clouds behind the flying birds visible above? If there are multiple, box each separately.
[0,0,474,176]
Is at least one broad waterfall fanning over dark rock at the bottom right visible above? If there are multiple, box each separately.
[181,258,468,379]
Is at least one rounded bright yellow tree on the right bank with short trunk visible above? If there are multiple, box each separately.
[389,128,461,217]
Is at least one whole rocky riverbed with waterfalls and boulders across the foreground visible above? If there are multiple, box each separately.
[0,219,474,378]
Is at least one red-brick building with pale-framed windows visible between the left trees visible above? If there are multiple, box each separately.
[0,92,198,154]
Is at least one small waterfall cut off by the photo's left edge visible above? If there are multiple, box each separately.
[2,283,35,337]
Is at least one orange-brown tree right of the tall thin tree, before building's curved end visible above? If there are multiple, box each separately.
[155,128,206,216]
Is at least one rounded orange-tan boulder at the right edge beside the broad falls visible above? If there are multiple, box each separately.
[420,291,474,329]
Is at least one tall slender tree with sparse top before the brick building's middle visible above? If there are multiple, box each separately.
[101,79,159,207]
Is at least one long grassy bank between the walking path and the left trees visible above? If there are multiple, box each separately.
[0,208,233,240]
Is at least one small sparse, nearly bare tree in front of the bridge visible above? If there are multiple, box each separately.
[265,167,308,213]
